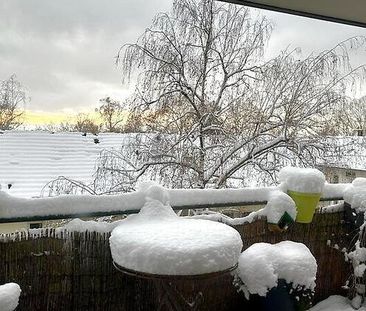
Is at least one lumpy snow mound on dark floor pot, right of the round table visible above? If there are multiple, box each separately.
[238,241,317,298]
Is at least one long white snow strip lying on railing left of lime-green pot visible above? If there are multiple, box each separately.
[0,183,277,218]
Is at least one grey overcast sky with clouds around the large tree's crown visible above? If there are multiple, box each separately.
[0,0,366,112]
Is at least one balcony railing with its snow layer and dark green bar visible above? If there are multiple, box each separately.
[0,184,349,223]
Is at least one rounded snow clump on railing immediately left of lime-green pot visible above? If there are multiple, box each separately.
[263,191,297,224]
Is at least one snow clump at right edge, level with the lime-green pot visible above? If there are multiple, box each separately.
[344,177,366,211]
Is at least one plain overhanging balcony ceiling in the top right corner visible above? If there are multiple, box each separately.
[221,0,366,27]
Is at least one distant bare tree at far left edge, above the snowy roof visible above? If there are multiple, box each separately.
[0,75,26,130]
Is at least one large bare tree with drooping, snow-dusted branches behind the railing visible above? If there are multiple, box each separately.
[90,0,365,193]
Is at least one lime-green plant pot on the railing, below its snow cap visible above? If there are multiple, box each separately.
[287,190,321,223]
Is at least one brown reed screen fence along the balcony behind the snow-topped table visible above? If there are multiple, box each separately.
[0,212,356,311]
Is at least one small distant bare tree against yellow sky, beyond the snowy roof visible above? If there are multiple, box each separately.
[96,97,126,133]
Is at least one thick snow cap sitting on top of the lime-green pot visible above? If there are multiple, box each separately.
[279,166,325,193]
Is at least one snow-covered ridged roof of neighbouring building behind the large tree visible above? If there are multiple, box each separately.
[0,131,366,198]
